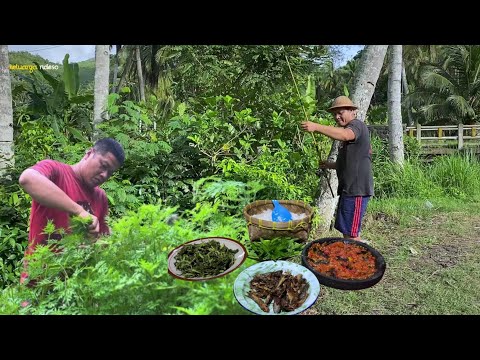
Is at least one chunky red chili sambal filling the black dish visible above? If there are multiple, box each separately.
[307,241,375,280]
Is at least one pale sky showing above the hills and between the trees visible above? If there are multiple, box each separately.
[8,45,364,66]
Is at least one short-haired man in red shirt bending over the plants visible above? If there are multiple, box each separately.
[19,138,125,283]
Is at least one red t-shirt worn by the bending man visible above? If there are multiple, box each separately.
[25,160,109,254]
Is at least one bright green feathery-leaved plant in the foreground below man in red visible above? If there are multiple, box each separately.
[0,205,253,314]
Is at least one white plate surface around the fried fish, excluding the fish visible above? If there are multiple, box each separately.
[233,260,320,315]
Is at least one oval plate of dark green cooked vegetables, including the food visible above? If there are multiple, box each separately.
[168,237,247,281]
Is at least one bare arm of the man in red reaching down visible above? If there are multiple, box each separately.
[18,169,99,233]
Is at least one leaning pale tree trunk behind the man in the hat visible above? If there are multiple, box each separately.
[316,45,388,231]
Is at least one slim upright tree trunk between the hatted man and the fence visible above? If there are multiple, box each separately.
[387,45,405,165]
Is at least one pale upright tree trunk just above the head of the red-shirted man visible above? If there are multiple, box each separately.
[93,45,110,141]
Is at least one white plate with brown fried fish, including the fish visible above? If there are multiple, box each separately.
[233,260,320,315]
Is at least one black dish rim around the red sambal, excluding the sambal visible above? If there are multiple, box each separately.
[302,238,387,290]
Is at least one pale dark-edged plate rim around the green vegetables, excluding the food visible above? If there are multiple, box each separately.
[168,237,247,281]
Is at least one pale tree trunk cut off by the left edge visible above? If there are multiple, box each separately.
[0,45,15,177]
